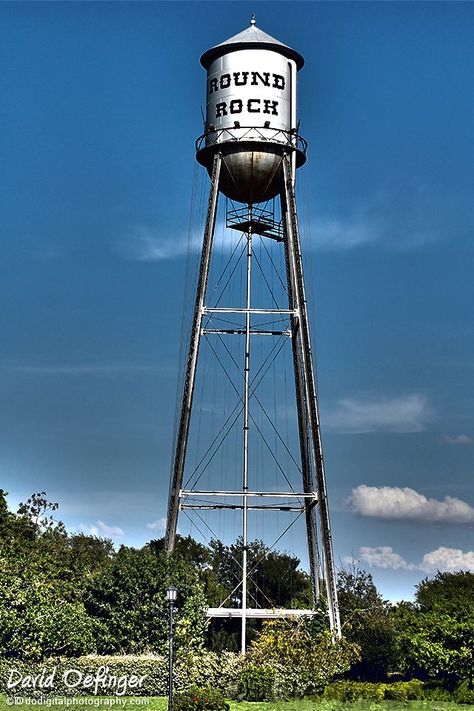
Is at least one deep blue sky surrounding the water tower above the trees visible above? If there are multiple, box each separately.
[0,2,474,599]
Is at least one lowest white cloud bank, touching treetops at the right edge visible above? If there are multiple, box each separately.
[359,546,474,573]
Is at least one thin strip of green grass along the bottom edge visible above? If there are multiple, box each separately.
[0,694,469,711]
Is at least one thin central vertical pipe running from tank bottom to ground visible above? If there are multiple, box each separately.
[241,205,252,654]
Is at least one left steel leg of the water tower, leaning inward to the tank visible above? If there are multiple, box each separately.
[165,153,222,553]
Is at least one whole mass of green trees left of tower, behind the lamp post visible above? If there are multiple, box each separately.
[0,491,207,660]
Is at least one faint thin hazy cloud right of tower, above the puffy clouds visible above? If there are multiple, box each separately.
[324,393,433,434]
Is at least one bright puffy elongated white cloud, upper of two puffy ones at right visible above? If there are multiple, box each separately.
[347,484,474,524]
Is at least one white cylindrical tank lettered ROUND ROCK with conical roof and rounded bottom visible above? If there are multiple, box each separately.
[197,19,305,203]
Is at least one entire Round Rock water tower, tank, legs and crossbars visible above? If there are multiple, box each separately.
[166,17,341,651]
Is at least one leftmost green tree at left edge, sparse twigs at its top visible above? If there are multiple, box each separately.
[0,492,95,660]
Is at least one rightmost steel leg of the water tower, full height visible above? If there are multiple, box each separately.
[281,155,341,637]
